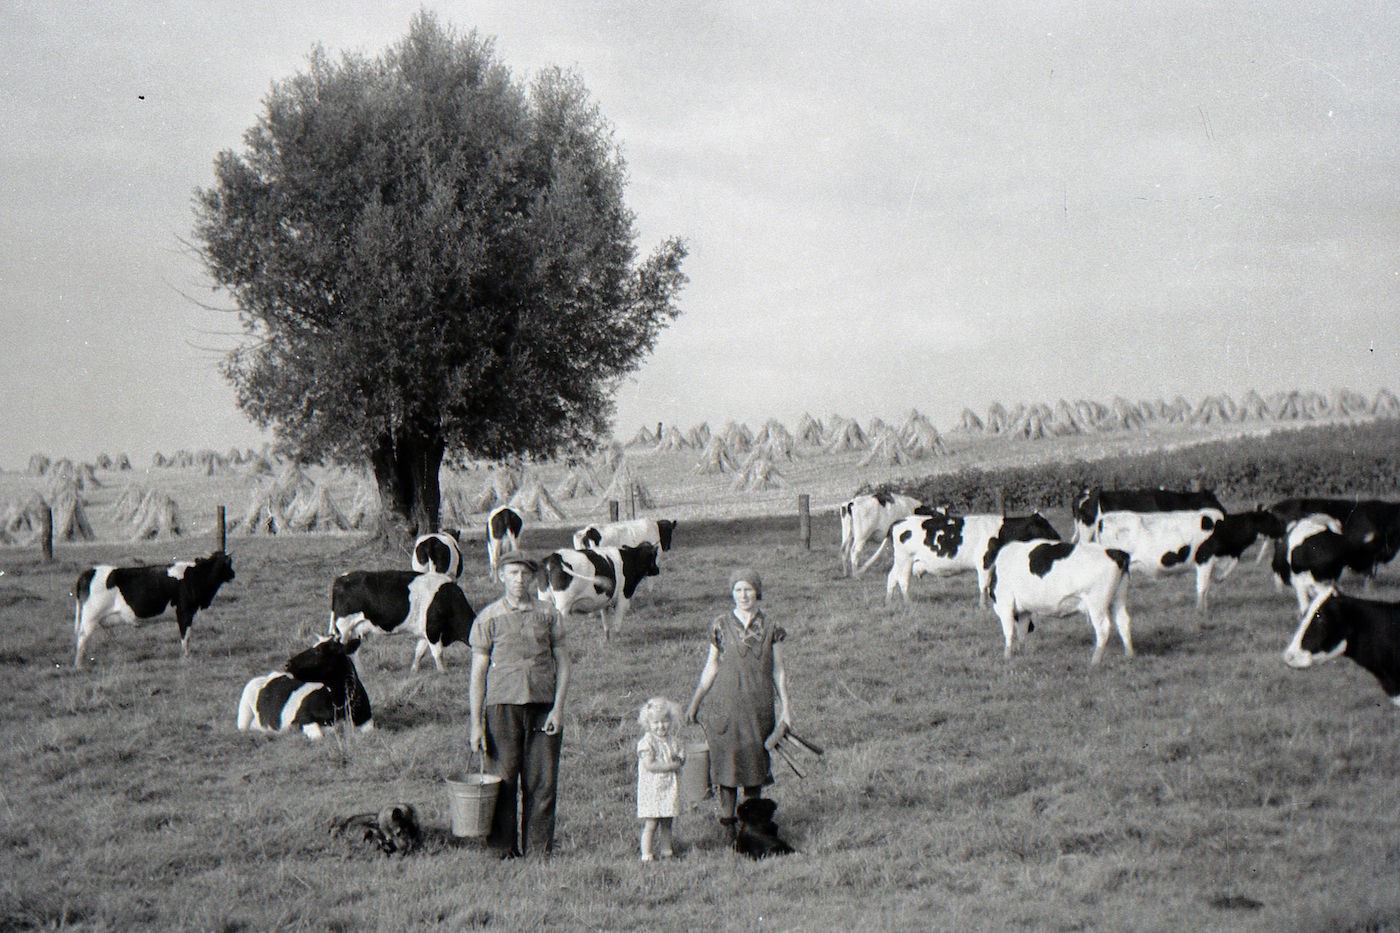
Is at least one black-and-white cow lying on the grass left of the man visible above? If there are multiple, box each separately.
[238,637,374,738]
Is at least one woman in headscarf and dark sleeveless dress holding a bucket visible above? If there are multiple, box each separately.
[686,567,791,841]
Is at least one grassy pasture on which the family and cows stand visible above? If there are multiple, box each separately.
[0,504,1400,933]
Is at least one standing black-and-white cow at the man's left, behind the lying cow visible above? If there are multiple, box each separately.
[330,570,476,674]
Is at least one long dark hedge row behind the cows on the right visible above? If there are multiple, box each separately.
[875,420,1400,513]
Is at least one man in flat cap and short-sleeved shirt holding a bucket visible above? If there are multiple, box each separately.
[468,551,570,859]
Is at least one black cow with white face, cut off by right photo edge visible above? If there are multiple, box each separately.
[1284,587,1400,706]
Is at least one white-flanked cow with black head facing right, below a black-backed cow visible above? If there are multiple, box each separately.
[1096,507,1282,615]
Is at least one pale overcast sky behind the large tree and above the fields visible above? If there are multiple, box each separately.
[0,0,1400,469]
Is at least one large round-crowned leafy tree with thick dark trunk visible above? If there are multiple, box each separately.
[195,13,686,532]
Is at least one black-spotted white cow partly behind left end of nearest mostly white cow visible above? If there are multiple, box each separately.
[861,511,1060,607]
